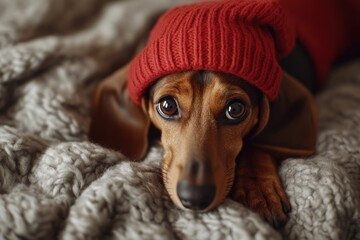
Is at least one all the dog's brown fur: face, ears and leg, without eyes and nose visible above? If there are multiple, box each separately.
[90,64,316,226]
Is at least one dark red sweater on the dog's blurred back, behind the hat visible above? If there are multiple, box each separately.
[280,0,360,86]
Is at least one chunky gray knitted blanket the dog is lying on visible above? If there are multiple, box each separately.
[0,0,360,240]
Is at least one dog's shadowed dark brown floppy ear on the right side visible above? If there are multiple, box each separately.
[252,72,317,158]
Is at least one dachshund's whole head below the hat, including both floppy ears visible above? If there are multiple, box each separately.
[90,64,316,210]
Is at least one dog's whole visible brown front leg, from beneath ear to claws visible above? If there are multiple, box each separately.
[230,147,291,228]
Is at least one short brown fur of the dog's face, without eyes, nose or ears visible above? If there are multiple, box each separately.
[146,72,258,210]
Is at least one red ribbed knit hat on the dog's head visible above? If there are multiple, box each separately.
[128,0,296,104]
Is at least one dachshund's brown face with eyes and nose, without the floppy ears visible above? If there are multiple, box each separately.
[144,71,268,210]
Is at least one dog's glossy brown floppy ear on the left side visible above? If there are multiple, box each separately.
[89,66,150,160]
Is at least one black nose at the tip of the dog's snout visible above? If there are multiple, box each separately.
[176,180,216,210]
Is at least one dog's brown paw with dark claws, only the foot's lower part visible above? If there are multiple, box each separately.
[230,174,291,228]
